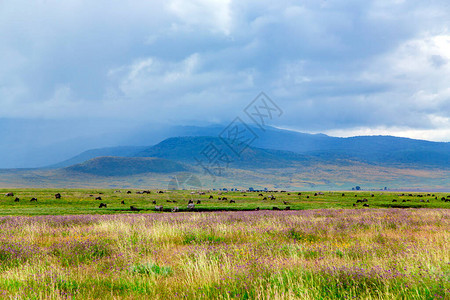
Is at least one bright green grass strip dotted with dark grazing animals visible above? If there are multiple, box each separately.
[0,189,450,215]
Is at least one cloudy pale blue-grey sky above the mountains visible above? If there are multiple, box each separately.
[0,0,450,141]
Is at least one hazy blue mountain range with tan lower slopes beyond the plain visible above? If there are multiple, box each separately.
[0,126,450,188]
